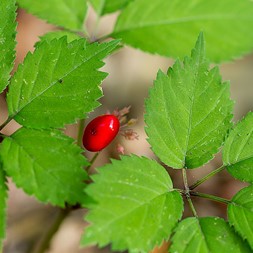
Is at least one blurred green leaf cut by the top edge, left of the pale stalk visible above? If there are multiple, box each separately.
[17,0,87,31]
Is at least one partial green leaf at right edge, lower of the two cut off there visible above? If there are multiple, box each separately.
[228,186,253,250]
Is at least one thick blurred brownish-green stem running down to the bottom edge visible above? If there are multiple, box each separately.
[32,208,71,253]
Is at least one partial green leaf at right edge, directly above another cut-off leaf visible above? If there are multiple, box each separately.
[223,112,253,183]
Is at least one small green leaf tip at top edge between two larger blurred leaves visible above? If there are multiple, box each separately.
[90,0,133,16]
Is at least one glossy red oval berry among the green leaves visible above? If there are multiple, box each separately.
[83,114,120,152]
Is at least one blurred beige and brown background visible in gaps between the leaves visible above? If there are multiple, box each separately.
[0,3,253,253]
